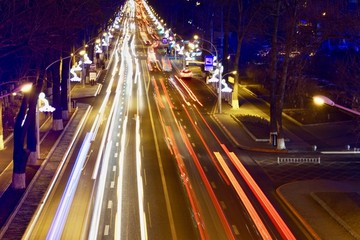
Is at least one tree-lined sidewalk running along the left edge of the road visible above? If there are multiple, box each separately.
[0,84,101,239]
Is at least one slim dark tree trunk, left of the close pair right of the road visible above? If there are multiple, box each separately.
[270,0,281,145]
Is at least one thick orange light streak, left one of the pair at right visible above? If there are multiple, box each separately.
[214,152,272,239]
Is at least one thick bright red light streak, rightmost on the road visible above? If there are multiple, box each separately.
[224,149,296,240]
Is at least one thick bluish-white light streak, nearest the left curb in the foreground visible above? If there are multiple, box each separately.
[46,133,91,239]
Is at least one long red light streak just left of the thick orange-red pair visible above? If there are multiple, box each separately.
[179,126,235,239]
